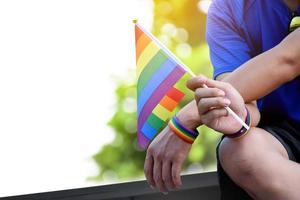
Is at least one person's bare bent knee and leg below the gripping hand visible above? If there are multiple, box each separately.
[219,128,300,200]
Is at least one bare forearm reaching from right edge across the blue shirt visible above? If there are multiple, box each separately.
[222,29,300,102]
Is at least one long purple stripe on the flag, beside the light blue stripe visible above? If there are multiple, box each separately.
[138,66,186,146]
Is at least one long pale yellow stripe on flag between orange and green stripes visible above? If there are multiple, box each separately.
[137,42,160,77]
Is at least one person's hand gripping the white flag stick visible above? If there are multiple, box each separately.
[187,76,247,134]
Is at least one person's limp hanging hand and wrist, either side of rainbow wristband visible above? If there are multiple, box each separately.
[144,101,200,193]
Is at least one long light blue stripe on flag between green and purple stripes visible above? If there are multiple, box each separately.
[137,59,177,115]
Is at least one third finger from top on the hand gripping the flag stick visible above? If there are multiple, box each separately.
[198,97,230,115]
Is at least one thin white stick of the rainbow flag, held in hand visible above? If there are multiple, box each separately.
[133,19,250,130]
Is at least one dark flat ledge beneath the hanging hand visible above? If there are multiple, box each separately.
[0,172,220,200]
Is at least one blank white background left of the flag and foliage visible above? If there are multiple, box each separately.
[0,0,152,196]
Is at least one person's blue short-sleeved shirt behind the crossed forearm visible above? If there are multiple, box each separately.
[206,0,300,123]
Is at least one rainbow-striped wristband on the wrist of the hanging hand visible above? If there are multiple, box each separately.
[168,115,199,144]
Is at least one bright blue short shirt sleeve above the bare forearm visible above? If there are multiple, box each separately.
[206,0,251,79]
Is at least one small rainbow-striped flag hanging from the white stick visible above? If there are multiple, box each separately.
[135,22,192,149]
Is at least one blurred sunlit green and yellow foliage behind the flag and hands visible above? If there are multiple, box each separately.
[93,0,219,180]
